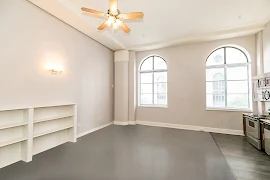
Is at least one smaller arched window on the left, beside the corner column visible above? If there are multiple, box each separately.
[139,56,167,106]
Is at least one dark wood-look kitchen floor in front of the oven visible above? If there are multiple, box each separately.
[212,133,270,180]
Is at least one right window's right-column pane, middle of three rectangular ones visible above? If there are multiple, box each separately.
[227,81,248,94]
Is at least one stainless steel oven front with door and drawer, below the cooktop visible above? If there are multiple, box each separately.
[246,116,262,150]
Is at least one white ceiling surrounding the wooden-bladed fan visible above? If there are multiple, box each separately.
[29,0,270,51]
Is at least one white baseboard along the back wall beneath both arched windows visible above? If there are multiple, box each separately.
[136,120,243,136]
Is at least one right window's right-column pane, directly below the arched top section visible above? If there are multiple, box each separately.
[227,66,248,80]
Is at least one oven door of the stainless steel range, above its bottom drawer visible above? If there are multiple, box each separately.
[246,117,261,139]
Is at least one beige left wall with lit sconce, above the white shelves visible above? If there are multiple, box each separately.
[0,0,113,133]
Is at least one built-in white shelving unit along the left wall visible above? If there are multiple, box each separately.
[0,104,77,168]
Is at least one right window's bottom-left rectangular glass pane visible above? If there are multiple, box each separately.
[206,93,226,108]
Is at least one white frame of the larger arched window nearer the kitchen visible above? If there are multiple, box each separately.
[205,46,252,112]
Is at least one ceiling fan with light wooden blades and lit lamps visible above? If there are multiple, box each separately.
[81,0,144,33]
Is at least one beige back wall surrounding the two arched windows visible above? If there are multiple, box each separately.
[136,35,256,130]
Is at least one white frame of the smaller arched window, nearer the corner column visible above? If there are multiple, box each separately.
[137,55,168,108]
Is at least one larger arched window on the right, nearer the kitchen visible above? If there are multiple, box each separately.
[206,46,251,109]
